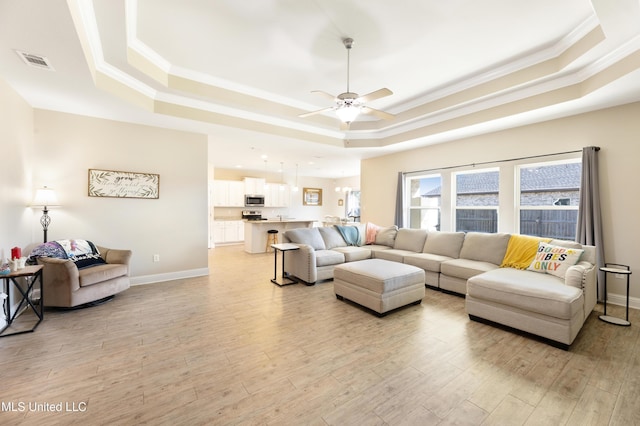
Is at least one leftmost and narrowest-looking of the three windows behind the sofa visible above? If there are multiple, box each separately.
[405,175,442,231]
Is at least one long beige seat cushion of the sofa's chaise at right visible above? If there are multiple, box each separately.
[467,268,583,319]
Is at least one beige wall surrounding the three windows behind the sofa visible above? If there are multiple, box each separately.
[361,103,640,306]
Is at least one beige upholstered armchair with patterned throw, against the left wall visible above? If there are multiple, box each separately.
[37,246,132,308]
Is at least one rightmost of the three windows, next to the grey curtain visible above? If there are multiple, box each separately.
[516,160,582,240]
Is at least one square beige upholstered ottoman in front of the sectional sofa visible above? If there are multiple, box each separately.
[333,259,425,316]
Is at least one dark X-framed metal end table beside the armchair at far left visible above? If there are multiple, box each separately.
[0,265,44,337]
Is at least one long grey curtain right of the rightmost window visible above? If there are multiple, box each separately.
[576,146,604,300]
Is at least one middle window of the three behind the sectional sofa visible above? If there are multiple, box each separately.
[453,169,500,232]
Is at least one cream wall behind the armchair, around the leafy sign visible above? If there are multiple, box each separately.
[30,110,208,284]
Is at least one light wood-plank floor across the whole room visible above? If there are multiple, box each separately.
[0,246,640,426]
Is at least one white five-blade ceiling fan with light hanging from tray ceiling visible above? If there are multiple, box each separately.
[299,38,395,128]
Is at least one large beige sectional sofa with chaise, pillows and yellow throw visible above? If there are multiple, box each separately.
[283,225,597,348]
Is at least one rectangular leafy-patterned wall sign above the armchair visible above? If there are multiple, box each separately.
[89,169,160,199]
